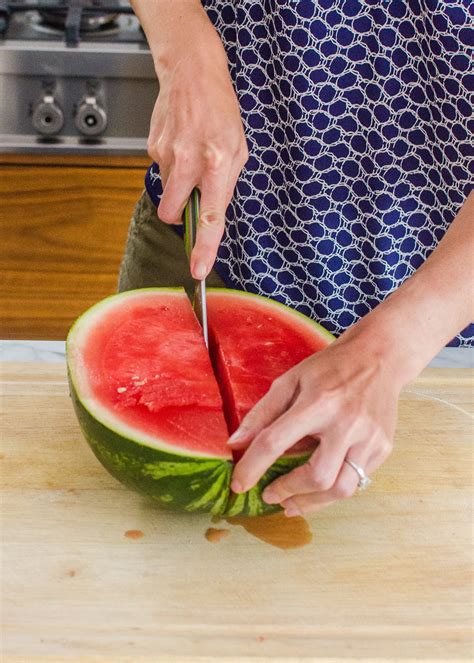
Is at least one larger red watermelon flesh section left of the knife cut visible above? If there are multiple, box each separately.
[81,290,231,458]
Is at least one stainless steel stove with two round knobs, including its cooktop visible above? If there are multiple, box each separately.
[0,0,158,155]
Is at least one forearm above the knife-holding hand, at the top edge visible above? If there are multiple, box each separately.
[131,0,227,78]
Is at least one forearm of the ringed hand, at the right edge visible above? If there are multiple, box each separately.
[341,192,474,385]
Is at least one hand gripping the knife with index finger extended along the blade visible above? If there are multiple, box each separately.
[144,3,248,279]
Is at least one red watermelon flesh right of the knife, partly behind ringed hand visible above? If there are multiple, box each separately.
[208,290,328,453]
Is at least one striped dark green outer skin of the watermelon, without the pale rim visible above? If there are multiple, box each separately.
[69,370,309,516]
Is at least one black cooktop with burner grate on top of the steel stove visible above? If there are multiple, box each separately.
[0,0,146,47]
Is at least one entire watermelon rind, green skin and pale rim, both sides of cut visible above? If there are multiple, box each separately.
[66,288,335,516]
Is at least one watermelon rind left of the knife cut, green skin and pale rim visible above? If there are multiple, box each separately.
[66,288,232,515]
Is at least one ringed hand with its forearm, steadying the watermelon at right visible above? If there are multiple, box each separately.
[229,188,474,515]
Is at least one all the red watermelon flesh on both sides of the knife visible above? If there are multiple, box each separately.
[70,289,334,466]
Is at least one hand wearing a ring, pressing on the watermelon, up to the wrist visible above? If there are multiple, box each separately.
[229,328,403,516]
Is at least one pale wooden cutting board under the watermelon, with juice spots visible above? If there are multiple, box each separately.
[1,363,474,663]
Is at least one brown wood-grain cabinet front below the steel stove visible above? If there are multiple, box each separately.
[0,155,149,340]
